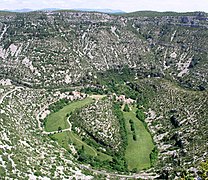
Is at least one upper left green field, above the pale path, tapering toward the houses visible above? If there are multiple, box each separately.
[45,98,93,132]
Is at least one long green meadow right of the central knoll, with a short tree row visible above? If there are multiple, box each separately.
[124,107,154,170]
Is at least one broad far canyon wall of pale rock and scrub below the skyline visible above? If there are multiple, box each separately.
[0,11,208,89]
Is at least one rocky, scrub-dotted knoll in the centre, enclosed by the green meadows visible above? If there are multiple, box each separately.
[70,99,122,151]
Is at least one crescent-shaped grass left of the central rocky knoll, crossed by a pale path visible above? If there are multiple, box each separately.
[45,97,112,161]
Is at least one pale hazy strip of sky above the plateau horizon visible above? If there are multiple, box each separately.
[0,0,208,12]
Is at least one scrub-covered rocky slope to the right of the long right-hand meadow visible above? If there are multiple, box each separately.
[135,79,208,179]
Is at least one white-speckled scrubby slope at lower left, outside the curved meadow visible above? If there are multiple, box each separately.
[0,86,91,179]
